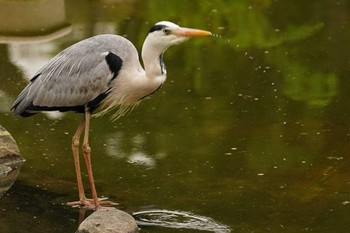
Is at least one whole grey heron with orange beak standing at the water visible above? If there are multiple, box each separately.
[11,21,211,209]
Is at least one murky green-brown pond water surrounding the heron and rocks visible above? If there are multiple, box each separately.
[0,0,350,233]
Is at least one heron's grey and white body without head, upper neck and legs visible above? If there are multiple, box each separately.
[13,35,166,116]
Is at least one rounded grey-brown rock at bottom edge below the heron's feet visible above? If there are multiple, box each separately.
[76,207,139,233]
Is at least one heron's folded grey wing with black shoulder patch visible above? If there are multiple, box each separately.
[11,36,123,116]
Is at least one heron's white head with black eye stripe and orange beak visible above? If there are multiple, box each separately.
[147,21,211,50]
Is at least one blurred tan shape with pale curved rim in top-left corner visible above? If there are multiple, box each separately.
[0,0,70,43]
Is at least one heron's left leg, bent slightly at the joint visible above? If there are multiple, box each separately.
[72,116,86,203]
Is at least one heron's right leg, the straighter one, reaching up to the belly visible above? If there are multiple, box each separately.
[83,110,100,209]
